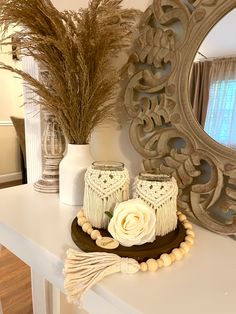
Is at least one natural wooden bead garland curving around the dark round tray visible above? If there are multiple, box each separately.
[77,210,195,272]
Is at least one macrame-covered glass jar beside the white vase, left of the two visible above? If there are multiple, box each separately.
[83,161,129,229]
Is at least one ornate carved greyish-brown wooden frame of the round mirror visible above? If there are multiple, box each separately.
[125,0,236,235]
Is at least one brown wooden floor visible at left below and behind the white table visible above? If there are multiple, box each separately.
[0,181,33,314]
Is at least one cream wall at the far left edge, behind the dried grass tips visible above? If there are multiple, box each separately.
[0,27,24,181]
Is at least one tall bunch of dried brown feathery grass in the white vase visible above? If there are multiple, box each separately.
[0,0,137,144]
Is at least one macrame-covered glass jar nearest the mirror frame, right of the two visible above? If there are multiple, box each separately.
[134,172,178,236]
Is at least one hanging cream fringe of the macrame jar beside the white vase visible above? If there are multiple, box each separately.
[83,184,129,229]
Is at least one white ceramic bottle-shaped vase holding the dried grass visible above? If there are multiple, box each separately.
[59,144,94,206]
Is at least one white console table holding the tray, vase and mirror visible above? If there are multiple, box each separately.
[0,185,236,314]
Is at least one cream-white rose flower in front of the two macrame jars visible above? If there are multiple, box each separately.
[108,198,156,247]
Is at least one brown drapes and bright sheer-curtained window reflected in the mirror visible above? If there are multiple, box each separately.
[190,58,236,149]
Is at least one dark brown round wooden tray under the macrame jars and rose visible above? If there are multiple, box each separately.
[71,217,186,262]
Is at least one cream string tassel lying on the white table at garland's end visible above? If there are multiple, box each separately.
[64,249,140,304]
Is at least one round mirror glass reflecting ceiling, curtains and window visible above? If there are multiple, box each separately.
[189,9,236,150]
